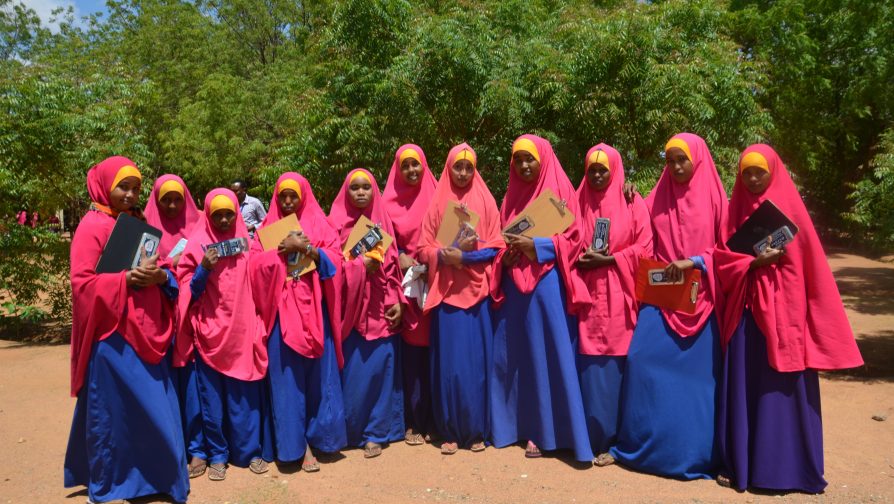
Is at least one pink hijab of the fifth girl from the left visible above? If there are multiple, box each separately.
[329,168,406,341]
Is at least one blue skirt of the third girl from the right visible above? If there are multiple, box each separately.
[577,354,627,453]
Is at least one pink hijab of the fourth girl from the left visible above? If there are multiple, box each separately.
[251,172,341,359]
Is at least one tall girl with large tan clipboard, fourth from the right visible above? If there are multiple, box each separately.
[489,135,593,462]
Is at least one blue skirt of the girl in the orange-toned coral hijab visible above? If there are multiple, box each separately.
[431,299,494,447]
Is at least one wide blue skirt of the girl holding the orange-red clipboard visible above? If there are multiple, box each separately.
[610,305,720,479]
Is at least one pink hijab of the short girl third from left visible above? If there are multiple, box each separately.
[174,189,267,381]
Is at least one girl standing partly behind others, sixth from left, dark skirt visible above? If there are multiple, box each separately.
[382,144,438,445]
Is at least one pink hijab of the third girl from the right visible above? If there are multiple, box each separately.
[571,143,652,355]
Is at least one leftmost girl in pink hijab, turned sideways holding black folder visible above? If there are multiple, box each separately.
[65,156,189,502]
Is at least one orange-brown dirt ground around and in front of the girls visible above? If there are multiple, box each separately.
[0,253,894,504]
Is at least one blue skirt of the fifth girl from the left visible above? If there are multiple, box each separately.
[341,330,404,447]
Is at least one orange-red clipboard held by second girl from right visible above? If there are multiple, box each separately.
[636,257,702,313]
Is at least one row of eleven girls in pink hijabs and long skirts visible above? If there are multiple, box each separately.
[65,133,862,502]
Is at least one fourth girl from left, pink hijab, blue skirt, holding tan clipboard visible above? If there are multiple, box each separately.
[251,172,347,472]
